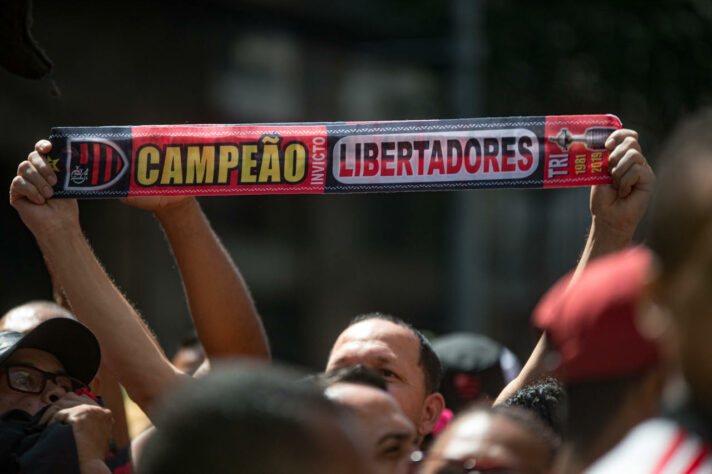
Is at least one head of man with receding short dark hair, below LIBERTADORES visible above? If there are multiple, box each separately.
[326,313,444,437]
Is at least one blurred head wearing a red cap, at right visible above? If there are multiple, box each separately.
[533,247,665,466]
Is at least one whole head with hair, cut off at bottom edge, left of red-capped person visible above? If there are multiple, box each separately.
[422,406,559,474]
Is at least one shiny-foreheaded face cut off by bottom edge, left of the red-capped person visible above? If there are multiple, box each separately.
[423,412,551,474]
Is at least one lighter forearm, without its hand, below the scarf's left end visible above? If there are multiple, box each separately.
[37,228,186,412]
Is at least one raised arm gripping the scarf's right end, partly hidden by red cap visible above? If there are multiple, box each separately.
[495,129,655,404]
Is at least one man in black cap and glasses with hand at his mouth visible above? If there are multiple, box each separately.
[0,318,112,474]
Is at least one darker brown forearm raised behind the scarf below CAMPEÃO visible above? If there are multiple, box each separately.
[156,199,270,358]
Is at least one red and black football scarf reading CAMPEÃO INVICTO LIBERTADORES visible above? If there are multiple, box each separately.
[48,115,621,198]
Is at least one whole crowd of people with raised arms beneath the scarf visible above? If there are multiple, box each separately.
[0,111,712,474]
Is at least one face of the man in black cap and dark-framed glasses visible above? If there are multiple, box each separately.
[0,349,67,415]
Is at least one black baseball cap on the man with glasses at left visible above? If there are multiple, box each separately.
[0,318,101,384]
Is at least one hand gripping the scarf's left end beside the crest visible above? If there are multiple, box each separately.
[10,140,79,237]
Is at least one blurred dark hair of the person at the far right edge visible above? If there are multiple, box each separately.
[648,109,712,277]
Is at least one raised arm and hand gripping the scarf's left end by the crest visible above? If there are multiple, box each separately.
[10,140,186,416]
